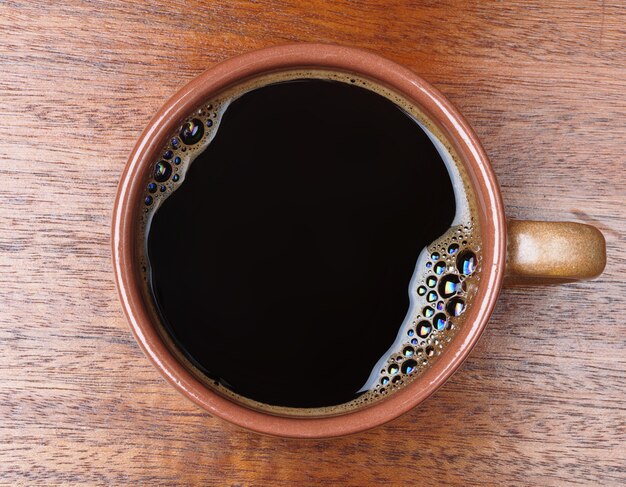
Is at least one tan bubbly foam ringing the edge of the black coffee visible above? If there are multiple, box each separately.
[137,70,481,417]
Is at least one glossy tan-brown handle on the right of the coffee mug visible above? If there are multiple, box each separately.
[505,220,606,285]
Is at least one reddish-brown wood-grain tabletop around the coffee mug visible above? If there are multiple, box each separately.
[0,0,626,486]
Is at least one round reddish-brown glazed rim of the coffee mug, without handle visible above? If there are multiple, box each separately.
[112,44,506,438]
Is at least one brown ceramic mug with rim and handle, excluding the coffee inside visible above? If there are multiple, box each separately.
[112,44,606,438]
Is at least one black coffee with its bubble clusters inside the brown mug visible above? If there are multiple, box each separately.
[139,74,475,414]
